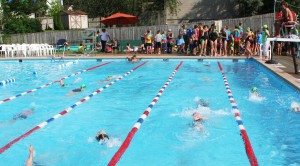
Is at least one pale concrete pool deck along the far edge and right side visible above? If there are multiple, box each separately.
[0,54,300,91]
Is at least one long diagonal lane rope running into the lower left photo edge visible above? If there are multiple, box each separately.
[0,62,147,154]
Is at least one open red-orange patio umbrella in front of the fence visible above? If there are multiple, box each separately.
[100,12,137,26]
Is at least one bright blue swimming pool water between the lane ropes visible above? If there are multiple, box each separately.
[0,59,300,166]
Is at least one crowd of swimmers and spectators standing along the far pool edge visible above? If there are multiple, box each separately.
[136,23,270,59]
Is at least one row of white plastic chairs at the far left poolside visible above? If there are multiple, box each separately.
[0,43,55,58]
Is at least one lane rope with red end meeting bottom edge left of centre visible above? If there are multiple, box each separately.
[108,61,183,166]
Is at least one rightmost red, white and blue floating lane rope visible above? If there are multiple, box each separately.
[218,62,258,166]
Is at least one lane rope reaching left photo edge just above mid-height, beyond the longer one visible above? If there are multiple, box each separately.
[0,62,111,105]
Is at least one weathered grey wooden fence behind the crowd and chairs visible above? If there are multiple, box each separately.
[8,13,274,45]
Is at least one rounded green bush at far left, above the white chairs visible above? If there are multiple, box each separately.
[3,17,42,34]
